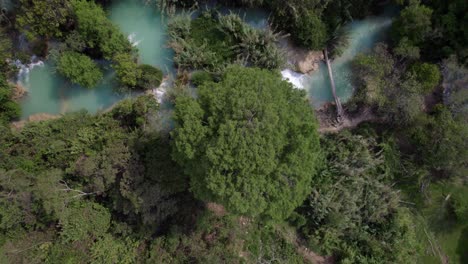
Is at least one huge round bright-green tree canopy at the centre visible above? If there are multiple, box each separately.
[173,66,319,219]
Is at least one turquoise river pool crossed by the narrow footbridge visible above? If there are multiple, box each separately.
[303,17,391,107]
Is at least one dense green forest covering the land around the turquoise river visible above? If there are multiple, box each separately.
[0,0,468,264]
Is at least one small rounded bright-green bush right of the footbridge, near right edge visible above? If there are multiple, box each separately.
[410,63,441,93]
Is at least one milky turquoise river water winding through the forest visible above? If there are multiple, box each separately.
[18,0,391,119]
